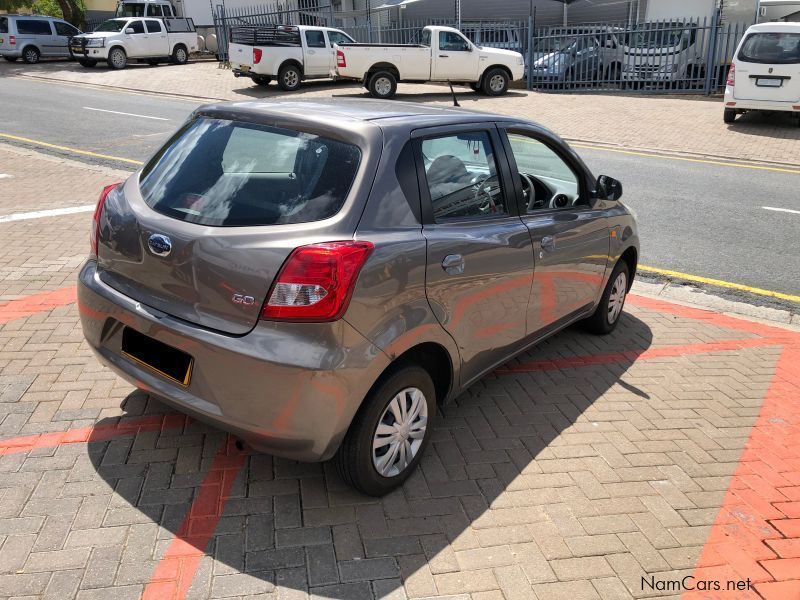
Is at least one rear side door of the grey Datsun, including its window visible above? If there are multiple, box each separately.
[415,123,533,385]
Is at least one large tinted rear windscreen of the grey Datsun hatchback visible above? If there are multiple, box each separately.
[140,118,361,227]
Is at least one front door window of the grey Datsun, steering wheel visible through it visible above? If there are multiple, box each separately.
[508,133,586,214]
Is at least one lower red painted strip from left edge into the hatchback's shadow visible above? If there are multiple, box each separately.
[0,413,189,456]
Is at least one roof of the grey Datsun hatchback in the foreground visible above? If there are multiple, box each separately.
[199,98,511,126]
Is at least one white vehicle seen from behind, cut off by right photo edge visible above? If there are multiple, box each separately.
[725,23,800,123]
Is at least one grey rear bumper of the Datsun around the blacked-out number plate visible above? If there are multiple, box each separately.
[78,260,389,461]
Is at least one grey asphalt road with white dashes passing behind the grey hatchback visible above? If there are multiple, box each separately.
[0,78,800,295]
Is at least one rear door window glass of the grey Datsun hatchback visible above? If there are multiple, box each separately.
[422,131,508,223]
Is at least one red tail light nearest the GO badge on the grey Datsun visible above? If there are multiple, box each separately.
[261,241,375,323]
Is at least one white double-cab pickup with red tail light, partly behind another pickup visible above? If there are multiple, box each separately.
[228,25,354,92]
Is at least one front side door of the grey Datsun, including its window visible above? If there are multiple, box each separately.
[500,124,611,333]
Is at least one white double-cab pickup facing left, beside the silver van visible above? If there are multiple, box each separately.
[70,17,197,69]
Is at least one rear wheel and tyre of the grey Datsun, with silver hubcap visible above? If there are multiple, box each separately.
[336,365,436,496]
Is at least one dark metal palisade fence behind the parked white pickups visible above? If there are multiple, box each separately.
[209,0,747,94]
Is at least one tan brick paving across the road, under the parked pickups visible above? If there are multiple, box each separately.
[0,62,800,165]
